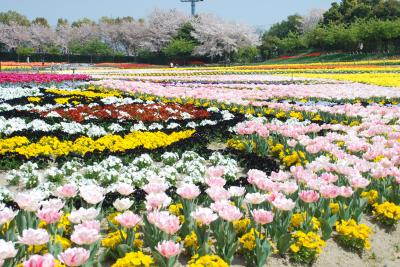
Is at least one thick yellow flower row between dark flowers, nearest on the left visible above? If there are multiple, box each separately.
[0,130,195,158]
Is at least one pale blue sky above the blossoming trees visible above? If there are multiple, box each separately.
[0,0,333,28]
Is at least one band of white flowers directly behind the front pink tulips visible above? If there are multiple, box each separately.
[0,151,239,198]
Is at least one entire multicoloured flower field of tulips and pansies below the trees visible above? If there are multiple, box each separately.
[0,60,400,267]
